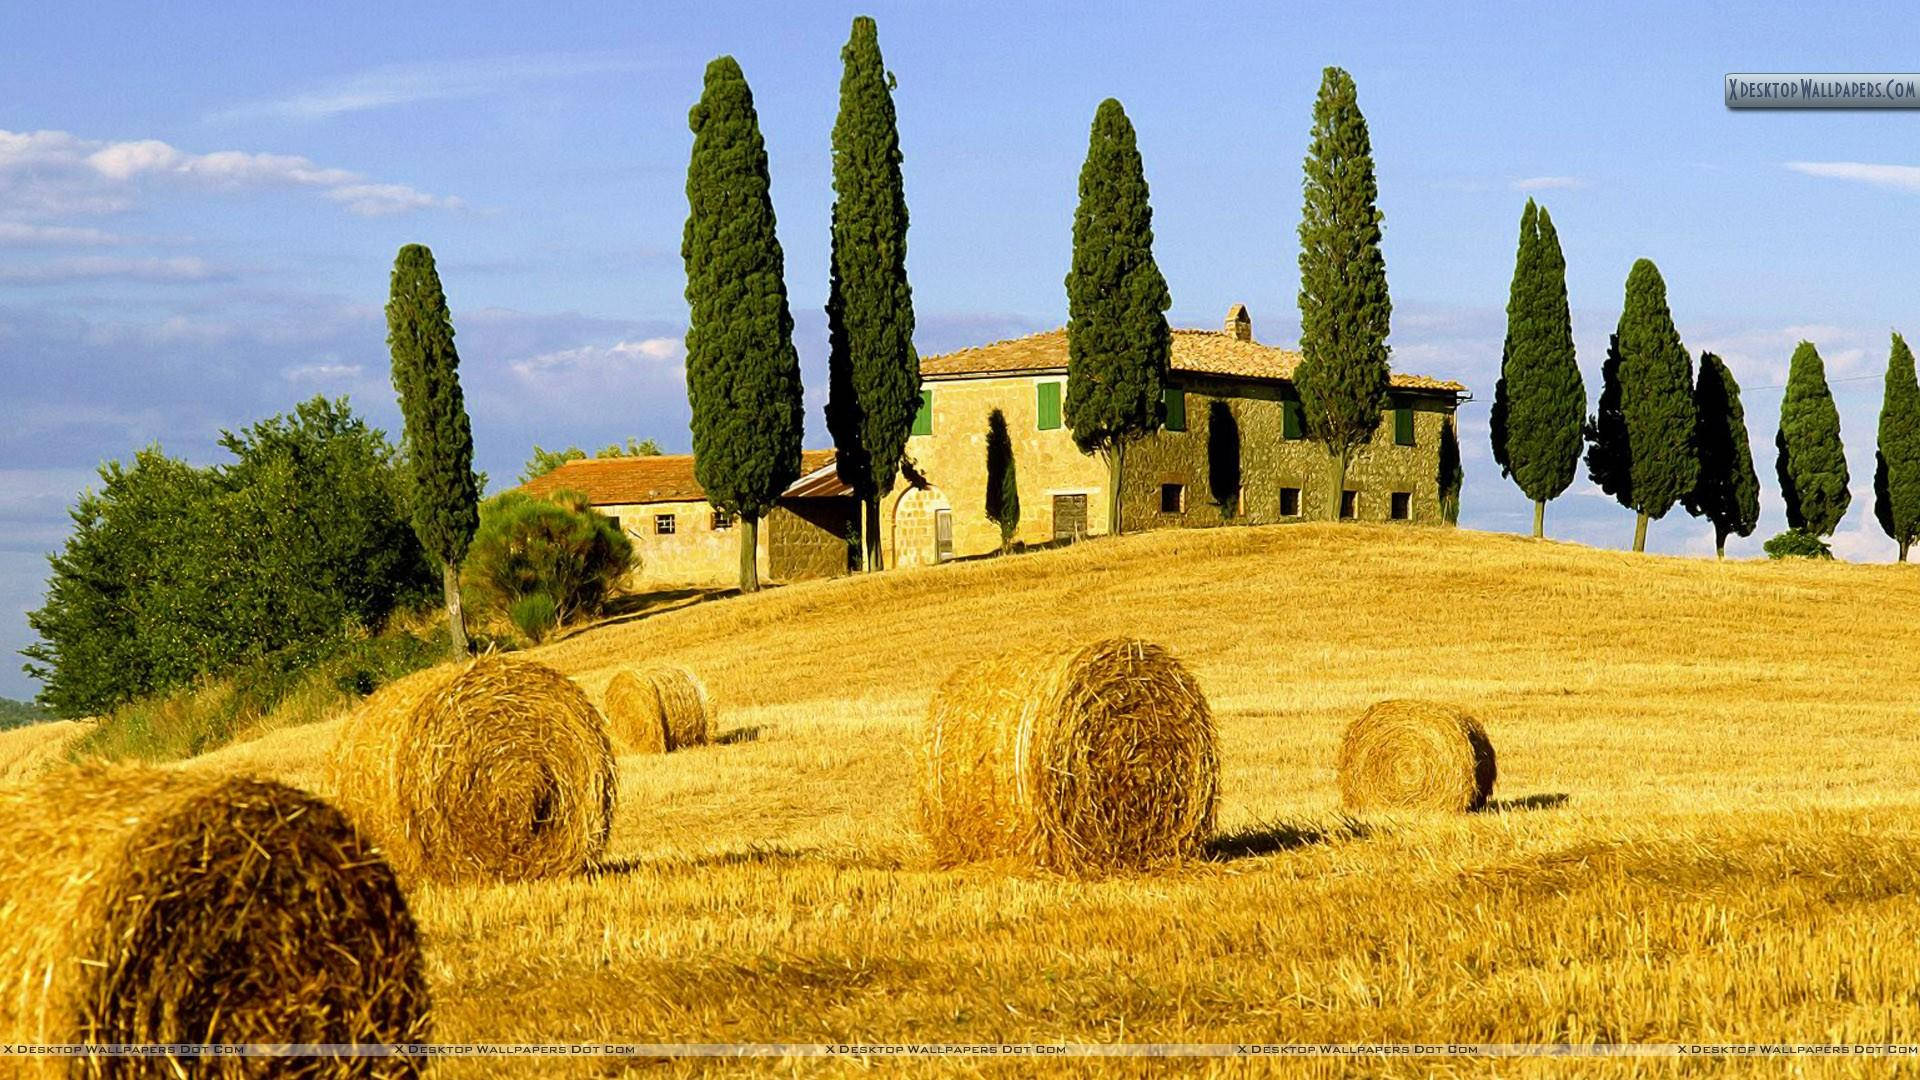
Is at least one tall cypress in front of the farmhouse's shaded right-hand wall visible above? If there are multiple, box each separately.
[1294,67,1394,521]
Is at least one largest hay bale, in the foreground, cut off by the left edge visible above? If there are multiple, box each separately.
[0,765,430,1076]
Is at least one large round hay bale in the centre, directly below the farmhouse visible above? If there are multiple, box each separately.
[920,638,1219,872]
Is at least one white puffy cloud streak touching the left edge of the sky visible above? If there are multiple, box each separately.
[0,131,465,217]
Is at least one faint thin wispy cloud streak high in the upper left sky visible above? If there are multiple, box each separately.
[207,52,643,121]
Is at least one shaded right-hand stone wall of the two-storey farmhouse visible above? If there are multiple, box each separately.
[1121,377,1452,530]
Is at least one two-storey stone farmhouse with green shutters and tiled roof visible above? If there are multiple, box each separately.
[881,304,1467,565]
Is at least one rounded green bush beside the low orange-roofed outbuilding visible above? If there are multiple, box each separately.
[463,490,634,642]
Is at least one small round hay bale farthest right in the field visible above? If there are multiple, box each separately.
[1334,700,1496,813]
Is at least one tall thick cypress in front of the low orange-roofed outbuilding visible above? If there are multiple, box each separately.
[680,56,804,592]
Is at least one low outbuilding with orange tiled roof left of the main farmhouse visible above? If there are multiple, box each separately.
[518,450,860,588]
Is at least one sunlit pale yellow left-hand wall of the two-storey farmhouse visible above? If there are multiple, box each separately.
[881,375,1106,567]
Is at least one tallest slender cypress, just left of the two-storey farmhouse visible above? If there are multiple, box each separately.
[828,15,920,571]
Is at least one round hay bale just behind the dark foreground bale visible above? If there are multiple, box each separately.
[330,657,616,880]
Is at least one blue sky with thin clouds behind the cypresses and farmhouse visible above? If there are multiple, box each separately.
[0,2,1920,696]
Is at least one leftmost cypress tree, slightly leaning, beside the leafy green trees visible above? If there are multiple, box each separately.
[386,244,480,653]
